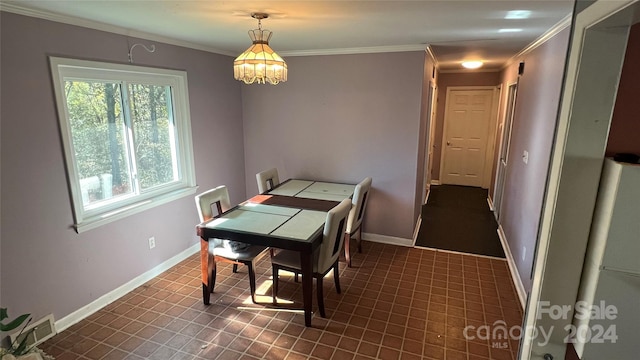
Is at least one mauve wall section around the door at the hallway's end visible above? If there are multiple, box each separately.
[432,71,500,180]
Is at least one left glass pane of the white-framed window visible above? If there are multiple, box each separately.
[65,81,132,208]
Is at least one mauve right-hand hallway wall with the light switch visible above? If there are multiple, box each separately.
[500,27,569,291]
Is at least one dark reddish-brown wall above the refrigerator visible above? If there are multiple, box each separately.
[606,24,640,156]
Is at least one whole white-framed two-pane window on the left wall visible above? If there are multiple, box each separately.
[50,57,196,232]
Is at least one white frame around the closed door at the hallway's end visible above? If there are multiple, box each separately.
[438,86,500,189]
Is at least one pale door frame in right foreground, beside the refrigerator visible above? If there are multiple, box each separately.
[519,0,640,360]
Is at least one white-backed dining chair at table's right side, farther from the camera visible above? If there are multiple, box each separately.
[344,177,371,267]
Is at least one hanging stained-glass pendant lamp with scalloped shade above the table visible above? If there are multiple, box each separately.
[233,13,287,85]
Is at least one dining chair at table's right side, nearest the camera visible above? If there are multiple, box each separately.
[271,199,351,317]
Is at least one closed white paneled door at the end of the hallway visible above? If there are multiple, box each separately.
[440,88,495,187]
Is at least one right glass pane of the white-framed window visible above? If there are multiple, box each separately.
[129,84,178,191]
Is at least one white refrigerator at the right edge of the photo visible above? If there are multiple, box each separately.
[572,159,640,360]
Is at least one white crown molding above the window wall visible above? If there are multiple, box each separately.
[0,2,237,56]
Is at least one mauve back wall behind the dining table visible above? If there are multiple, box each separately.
[242,51,425,242]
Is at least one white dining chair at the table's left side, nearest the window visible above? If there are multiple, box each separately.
[196,185,268,303]
